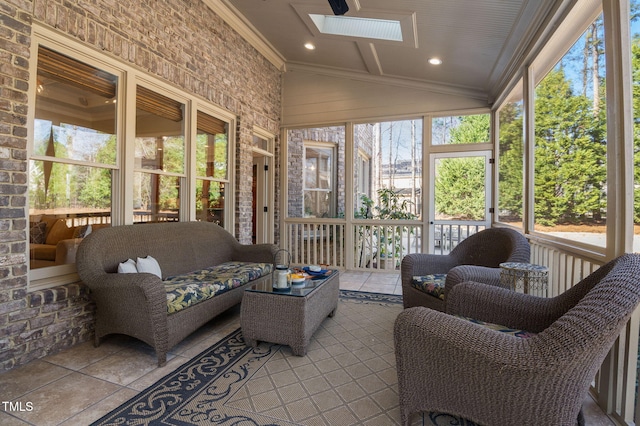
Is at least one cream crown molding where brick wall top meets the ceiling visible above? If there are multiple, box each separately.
[202,0,286,71]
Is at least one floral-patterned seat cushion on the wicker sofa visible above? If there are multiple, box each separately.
[163,262,272,314]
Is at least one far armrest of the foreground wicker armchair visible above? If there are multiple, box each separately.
[447,281,566,333]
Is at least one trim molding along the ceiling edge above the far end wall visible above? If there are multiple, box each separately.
[287,62,487,101]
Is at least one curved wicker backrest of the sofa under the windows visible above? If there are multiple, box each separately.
[76,222,240,278]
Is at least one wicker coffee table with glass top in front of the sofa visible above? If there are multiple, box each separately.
[240,270,340,356]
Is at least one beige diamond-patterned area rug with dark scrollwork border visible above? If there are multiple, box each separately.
[93,290,472,426]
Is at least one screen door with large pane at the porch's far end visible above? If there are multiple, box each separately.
[428,151,491,254]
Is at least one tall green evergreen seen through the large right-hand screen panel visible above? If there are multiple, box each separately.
[534,67,606,225]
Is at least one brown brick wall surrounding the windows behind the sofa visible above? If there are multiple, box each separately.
[0,0,281,371]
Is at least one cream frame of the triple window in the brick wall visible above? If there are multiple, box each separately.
[25,23,237,292]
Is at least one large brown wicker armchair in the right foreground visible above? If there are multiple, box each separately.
[394,254,640,425]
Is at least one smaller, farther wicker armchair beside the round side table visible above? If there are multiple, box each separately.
[400,228,531,312]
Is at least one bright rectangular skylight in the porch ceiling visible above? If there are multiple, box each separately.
[309,13,402,41]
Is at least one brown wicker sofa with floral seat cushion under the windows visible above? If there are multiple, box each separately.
[76,222,277,366]
